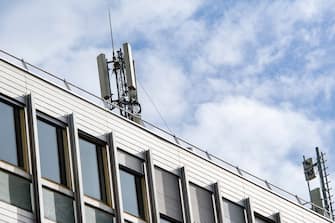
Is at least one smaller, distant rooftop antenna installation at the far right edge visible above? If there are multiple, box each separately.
[303,147,335,220]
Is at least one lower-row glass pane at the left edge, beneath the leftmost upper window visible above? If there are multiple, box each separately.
[0,171,32,211]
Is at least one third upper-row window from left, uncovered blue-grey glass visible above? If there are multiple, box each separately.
[79,138,107,202]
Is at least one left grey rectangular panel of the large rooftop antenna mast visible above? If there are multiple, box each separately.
[97,54,111,99]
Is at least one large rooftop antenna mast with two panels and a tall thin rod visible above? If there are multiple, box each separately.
[97,10,142,124]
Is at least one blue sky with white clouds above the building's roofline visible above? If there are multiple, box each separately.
[0,0,335,202]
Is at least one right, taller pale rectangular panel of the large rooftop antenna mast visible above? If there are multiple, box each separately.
[123,43,136,90]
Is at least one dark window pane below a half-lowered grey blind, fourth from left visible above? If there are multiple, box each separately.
[120,170,142,217]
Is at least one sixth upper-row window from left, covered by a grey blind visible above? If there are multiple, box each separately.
[190,184,215,223]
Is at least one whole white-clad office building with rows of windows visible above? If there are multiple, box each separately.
[0,51,332,223]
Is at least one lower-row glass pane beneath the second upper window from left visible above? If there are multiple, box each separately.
[43,188,75,223]
